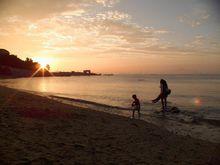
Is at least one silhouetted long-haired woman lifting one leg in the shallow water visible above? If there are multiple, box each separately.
[152,79,171,111]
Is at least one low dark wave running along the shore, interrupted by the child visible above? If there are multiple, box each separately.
[49,95,220,126]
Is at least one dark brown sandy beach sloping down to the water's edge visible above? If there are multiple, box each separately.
[0,86,220,165]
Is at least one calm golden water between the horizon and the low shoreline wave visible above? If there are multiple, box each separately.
[1,75,220,119]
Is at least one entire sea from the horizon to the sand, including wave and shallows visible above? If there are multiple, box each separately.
[0,74,220,143]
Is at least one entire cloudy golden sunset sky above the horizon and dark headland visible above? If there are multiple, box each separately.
[0,0,220,74]
